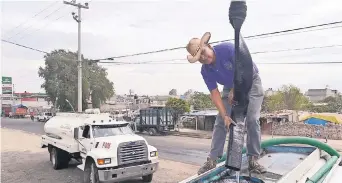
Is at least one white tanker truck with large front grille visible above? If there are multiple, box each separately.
[41,113,158,183]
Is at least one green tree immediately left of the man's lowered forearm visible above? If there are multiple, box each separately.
[190,91,215,110]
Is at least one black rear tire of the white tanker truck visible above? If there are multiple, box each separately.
[50,147,69,170]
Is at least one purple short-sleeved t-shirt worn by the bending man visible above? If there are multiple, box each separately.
[201,42,259,91]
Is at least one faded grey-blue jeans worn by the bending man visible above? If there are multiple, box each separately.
[209,74,264,159]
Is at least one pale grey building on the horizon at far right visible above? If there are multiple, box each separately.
[305,88,339,103]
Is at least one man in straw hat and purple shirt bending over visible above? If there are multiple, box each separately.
[186,32,266,174]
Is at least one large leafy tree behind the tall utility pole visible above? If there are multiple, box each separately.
[38,49,115,111]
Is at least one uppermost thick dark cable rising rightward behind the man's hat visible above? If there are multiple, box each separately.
[96,21,342,60]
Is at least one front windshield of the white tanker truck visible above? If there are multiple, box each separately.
[93,124,134,138]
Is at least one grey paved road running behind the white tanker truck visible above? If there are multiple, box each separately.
[1,118,210,165]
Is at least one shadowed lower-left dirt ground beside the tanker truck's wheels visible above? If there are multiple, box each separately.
[1,151,152,183]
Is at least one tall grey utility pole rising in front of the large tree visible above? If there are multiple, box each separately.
[63,0,89,112]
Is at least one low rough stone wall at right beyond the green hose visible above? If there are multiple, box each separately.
[273,122,342,140]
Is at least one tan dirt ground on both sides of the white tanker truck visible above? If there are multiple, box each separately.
[1,128,199,183]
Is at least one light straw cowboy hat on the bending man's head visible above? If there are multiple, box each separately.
[186,32,211,63]
